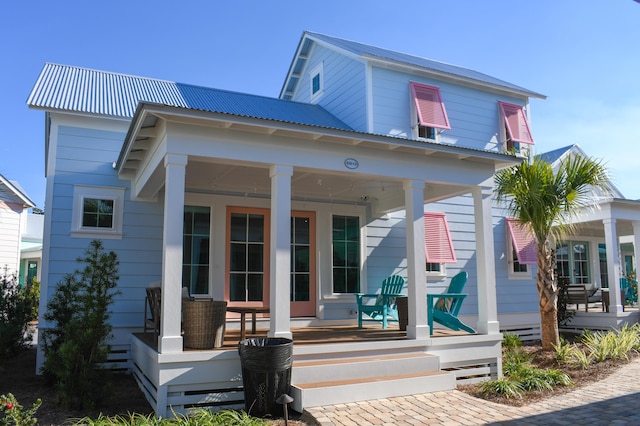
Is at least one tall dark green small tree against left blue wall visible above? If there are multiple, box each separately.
[42,240,119,409]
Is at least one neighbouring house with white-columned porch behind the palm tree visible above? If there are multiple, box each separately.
[540,145,640,330]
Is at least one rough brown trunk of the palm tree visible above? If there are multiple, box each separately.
[536,240,560,350]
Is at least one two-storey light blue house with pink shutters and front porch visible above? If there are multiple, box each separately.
[28,32,544,416]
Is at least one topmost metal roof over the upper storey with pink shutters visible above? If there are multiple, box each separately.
[303,32,545,98]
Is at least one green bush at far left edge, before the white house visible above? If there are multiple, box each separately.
[0,266,39,360]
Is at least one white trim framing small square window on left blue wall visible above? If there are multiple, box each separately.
[71,185,125,239]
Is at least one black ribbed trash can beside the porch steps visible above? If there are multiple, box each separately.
[238,337,293,417]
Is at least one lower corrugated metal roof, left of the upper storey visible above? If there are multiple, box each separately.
[27,63,352,130]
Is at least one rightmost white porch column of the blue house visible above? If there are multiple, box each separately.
[472,185,500,334]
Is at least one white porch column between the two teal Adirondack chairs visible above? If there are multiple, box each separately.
[402,179,429,340]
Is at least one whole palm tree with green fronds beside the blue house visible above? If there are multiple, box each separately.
[495,155,610,350]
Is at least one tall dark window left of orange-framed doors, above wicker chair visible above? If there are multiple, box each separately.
[182,206,211,295]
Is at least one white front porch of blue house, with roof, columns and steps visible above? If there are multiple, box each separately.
[116,103,519,416]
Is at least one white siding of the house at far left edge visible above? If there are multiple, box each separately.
[0,199,26,276]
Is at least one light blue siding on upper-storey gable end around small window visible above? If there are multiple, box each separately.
[293,44,367,132]
